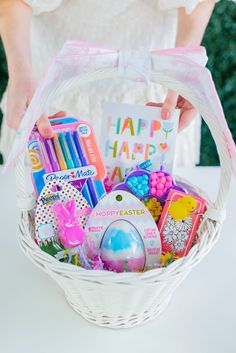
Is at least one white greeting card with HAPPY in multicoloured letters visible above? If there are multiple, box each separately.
[100,103,179,185]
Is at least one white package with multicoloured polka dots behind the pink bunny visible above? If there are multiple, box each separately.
[35,180,91,256]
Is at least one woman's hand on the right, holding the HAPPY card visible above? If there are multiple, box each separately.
[147,90,197,131]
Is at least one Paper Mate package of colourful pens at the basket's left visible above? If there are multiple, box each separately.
[28,117,106,207]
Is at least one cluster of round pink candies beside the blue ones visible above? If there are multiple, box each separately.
[150,172,173,197]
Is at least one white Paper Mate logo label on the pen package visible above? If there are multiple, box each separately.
[43,165,97,183]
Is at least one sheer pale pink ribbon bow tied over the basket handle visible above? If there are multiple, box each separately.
[4,41,236,175]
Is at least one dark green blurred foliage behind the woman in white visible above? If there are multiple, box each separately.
[0,0,236,165]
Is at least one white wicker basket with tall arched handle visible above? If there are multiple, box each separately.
[16,59,231,328]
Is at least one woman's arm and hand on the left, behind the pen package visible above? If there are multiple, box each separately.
[0,0,55,137]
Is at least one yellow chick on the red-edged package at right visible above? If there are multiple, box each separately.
[168,196,197,222]
